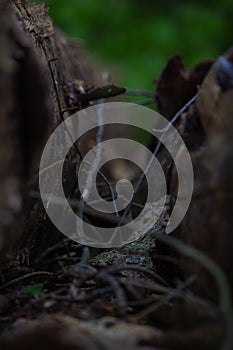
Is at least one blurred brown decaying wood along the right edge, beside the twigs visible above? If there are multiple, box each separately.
[177,52,233,294]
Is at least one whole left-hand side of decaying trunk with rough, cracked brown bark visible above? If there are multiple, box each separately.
[0,0,101,267]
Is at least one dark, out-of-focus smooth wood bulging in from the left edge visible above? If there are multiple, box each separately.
[0,1,49,263]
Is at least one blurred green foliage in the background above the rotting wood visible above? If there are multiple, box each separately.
[32,0,233,89]
